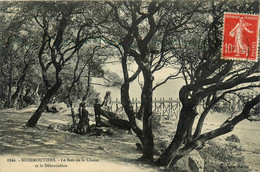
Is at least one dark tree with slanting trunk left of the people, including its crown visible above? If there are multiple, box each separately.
[25,2,106,127]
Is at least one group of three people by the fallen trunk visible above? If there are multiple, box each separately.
[76,91,112,134]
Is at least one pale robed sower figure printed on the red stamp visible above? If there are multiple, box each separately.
[229,17,253,56]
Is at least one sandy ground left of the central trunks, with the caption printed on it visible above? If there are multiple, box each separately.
[0,109,159,172]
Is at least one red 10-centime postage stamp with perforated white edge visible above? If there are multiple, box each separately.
[221,13,259,61]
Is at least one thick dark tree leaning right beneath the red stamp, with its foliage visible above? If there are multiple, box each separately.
[156,1,260,166]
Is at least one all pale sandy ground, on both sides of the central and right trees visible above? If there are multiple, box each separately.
[0,107,260,172]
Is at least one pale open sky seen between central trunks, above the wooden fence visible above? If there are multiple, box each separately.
[93,61,185,101]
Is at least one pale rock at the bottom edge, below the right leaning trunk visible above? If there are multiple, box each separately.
[189,150,204,172]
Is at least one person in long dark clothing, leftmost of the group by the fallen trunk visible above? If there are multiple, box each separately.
[77,102,90,134]
